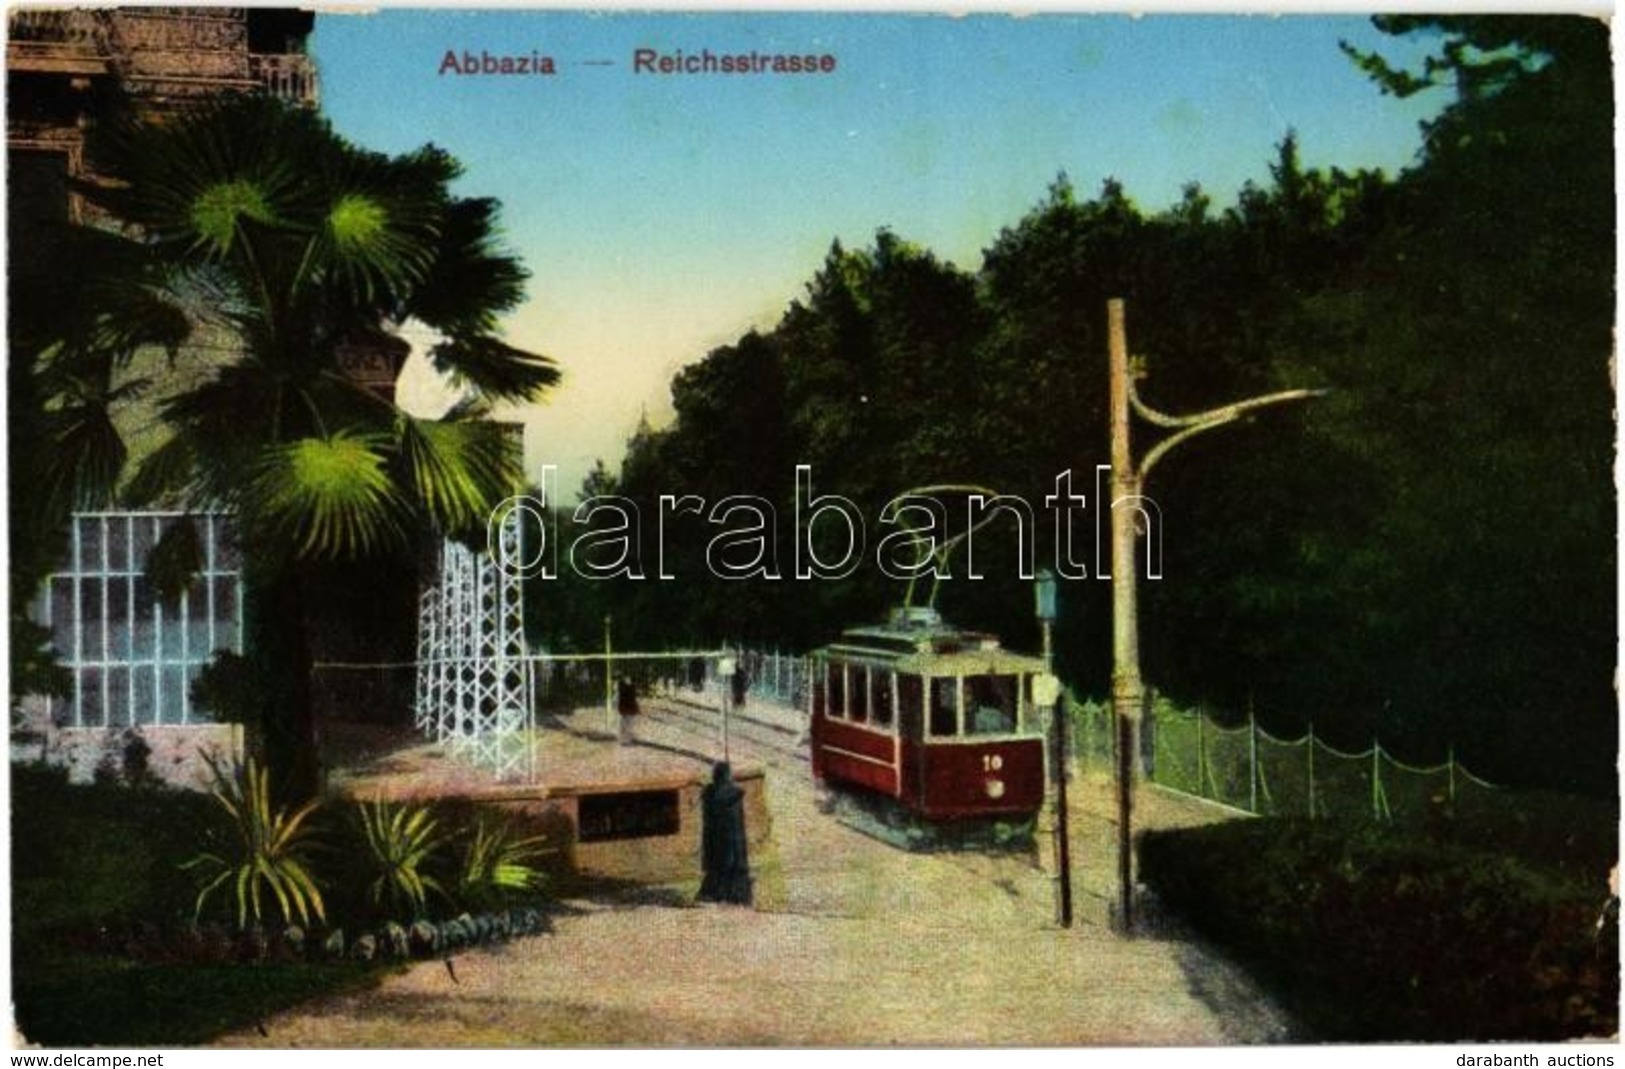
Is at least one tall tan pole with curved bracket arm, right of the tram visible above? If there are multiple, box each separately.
[1107,297,1324,934]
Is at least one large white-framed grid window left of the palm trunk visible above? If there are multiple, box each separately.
[36,512,242,728]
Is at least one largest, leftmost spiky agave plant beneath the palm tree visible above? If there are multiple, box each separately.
[182,754,327,926]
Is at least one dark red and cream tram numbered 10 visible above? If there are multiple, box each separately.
[811,609,1048,820]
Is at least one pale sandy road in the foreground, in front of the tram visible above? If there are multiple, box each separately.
[223,695,1290,1046]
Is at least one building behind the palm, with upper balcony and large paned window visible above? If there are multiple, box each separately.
[7,6,318,785]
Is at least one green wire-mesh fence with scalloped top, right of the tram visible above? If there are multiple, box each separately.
[1068,697,1502,820]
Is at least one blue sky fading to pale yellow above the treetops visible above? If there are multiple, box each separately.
[314,10,1445,491]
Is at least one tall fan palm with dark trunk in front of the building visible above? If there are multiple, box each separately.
[23,96,559,785]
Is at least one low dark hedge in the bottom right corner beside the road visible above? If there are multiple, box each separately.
[1141,820,1619,1041]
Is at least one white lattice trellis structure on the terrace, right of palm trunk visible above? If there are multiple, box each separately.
[416,515,536,780]
